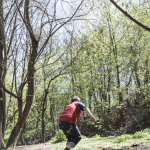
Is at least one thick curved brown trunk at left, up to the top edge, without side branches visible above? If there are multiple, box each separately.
[6,0,38,150]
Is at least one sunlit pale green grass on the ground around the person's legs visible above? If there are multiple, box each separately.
[46,129,150,150]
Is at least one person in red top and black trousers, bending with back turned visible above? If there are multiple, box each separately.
[59,96,96,150]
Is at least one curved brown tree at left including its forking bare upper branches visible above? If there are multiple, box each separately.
[5,0,84,150]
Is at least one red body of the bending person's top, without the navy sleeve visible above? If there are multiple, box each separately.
[59,102,81,123]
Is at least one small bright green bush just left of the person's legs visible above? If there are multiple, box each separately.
[51,130,66,143]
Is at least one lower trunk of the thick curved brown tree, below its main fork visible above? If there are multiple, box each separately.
[7,43,37,150]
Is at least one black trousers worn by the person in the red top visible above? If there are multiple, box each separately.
[59,121,81,147]
